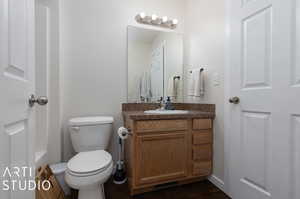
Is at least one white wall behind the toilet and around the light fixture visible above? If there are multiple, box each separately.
[60,0,185,159]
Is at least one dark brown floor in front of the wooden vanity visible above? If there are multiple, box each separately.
[105,180,230,199]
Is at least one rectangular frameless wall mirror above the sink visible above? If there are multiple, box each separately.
[127,26,183,103]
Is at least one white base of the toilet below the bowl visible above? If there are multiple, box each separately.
[78,184,105,199]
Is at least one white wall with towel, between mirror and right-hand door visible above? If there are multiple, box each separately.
[184,0,225,181]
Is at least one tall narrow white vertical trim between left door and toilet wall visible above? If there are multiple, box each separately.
[35,0,63,163]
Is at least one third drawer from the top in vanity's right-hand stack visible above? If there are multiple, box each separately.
[193,144,212,161]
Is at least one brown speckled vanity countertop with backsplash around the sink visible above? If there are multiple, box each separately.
[122,103,215,120]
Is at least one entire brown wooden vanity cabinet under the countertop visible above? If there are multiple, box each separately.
[125,119,213,195]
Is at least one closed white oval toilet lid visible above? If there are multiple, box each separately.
[68,150,112,173]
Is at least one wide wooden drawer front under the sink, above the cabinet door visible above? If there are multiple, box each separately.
[136,120,188,132]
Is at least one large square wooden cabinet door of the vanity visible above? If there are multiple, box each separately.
[136,131,188,185]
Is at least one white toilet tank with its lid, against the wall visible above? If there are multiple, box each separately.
[68,116,114,153]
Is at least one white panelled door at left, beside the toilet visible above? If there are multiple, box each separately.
[0,0,43,199]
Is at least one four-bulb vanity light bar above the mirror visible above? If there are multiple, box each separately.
[135,12,178,29]
